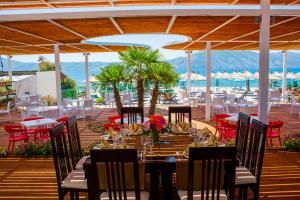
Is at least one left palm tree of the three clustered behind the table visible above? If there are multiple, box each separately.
[95,63,129,114]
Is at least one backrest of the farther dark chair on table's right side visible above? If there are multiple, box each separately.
[235,113,250,165]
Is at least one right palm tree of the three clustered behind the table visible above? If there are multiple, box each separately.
[147,62,178,115]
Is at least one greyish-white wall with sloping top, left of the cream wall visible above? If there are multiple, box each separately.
[12,75,37,98]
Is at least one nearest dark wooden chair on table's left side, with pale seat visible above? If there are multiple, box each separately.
[50,123,87,200]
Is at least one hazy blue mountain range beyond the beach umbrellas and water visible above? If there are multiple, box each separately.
[2,51,300,83]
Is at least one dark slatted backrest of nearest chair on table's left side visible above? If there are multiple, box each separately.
[50,124,71,189]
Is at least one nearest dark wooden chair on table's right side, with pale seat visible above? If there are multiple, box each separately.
[235,119,267,200]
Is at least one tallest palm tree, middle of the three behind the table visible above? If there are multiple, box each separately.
[119,47,161,107]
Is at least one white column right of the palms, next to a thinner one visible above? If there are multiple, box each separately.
[205,42,211,121]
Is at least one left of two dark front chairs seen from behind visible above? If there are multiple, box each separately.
[88,149,149,200]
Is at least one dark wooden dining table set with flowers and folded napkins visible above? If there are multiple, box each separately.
[83,123,223,199]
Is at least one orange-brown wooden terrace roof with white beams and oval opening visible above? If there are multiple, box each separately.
[0,9,300,55]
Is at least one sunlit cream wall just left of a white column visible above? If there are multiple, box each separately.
[36,71,57,100]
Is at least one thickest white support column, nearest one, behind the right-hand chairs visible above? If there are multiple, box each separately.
[259,0,270,123]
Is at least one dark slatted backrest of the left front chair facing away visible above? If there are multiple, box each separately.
[88,149,141,200]
